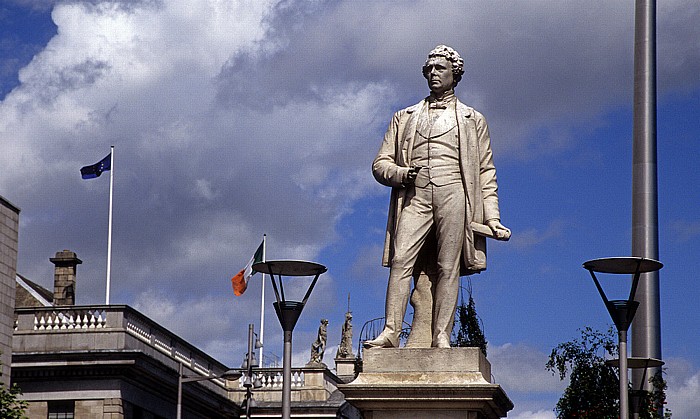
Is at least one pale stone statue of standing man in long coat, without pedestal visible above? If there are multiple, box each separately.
[364,45,510,348]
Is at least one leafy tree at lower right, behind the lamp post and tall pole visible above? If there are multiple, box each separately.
[546,327,671,419]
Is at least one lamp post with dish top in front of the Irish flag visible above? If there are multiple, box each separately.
[253,260,327,419]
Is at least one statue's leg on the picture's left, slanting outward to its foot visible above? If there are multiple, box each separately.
[382,185,433,346]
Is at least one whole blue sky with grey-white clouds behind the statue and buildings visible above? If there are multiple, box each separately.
[0,0,700,419]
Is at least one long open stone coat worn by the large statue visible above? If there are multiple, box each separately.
[372,100,500,275]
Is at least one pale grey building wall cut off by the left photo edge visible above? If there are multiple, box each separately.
[0,196,19,386]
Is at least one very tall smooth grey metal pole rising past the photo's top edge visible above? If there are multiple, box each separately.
[632,0,662,398]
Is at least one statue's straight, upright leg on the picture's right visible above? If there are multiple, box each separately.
[433,183,466,347]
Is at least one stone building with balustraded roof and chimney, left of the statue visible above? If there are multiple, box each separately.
[12,250,359,419]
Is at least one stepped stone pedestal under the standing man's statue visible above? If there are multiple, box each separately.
[338,348,513,419]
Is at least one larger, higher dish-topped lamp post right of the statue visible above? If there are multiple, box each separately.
[583,257,663,419]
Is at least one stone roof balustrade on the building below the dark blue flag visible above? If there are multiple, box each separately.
[15,305,227,386]
